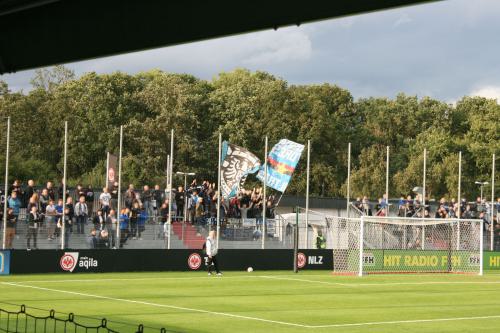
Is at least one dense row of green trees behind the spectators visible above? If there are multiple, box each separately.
[0,66,500,198]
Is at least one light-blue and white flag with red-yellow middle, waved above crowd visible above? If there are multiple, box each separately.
[257,139,304,192]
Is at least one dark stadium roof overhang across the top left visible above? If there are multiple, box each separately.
[0,0,439,74]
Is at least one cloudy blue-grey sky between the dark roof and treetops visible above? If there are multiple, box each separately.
[0,0,500,103]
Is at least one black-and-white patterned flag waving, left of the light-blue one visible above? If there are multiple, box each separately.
[220,141,260,198]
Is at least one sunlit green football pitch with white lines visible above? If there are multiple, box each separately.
[0,271,500,333]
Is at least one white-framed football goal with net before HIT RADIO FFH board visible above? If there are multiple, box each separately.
[329,216,483,276]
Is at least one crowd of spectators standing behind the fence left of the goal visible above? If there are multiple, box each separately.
[0,179,275,250]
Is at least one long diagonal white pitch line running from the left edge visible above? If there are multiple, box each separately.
[2,282,310,328]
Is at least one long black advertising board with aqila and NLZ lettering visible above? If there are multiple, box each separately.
[7,249,333,274]
